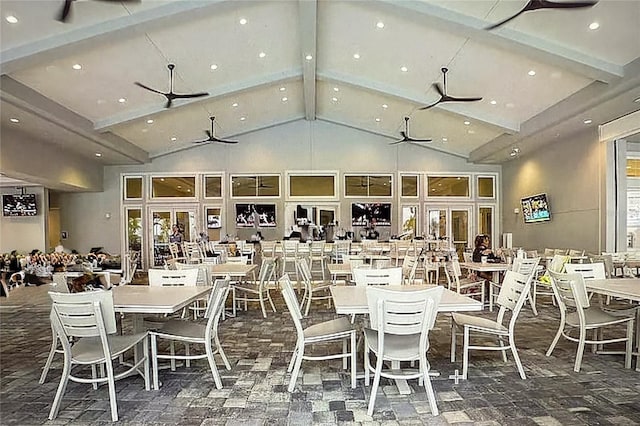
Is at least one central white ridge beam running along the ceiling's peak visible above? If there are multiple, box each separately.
[298,0,318,121]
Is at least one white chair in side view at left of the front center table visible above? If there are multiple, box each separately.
[278,274,356,392]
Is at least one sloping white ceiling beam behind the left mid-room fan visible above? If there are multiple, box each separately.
[94,69,304,132]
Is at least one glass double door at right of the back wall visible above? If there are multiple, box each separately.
[425,205,473,259]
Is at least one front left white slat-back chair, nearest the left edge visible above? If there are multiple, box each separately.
[49,291,150,422]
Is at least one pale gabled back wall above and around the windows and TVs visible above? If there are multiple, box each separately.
[60,120,500,253]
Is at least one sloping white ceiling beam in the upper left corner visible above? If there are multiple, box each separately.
[0,0,233,74]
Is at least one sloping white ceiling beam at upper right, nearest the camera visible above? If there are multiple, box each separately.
[377,0,624,83]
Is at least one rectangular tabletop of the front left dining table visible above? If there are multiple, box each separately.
[111,285,211,314]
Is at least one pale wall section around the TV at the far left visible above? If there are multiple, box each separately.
[0,186,49,253]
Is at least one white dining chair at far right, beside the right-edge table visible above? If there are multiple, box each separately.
[546,271,635,373]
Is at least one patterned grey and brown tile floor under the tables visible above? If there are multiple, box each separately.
[0,286,640,426]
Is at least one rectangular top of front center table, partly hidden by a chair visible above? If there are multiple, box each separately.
[331,285,482,315]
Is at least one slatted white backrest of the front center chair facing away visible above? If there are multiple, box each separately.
[367,286,444,342]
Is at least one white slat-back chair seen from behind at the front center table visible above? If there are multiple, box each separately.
[364,286,444,416]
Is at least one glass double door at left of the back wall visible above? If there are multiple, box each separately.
[149,206,197,266]
